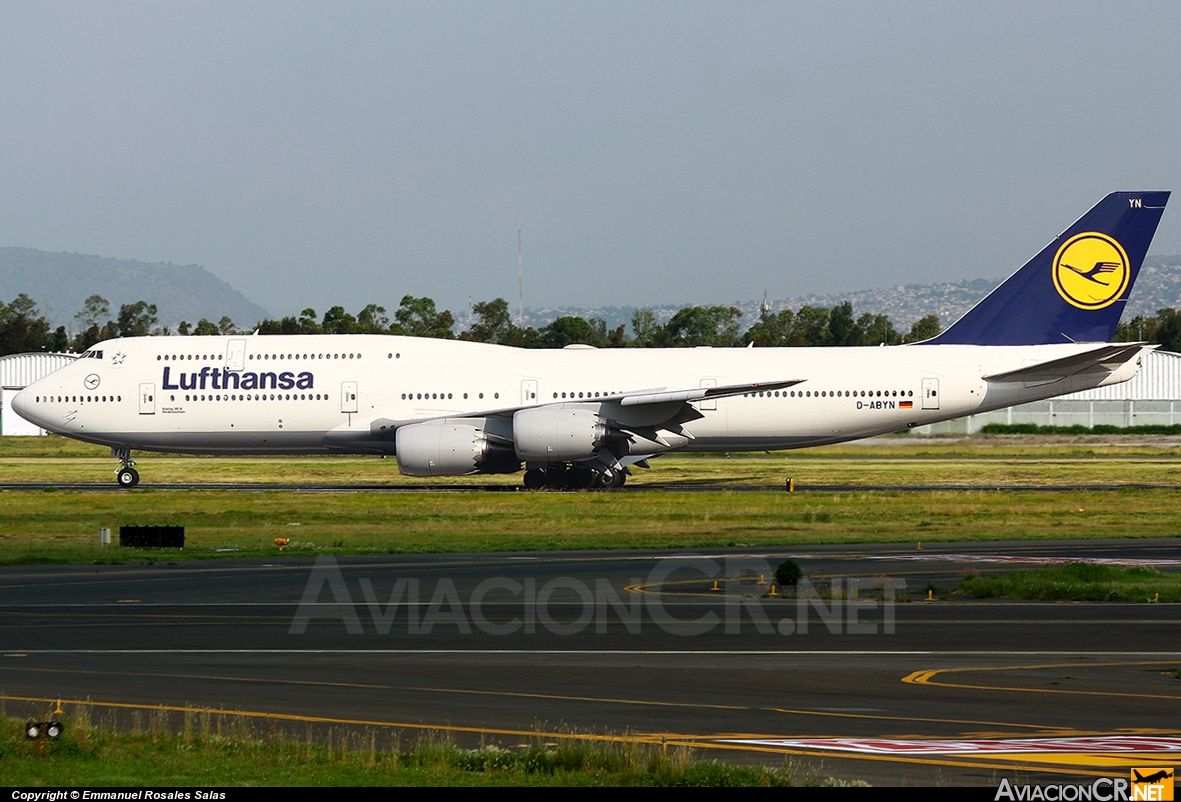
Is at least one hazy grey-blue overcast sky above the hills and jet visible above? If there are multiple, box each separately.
[0,0,1181,314]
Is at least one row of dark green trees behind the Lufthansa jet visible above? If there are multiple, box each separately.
[20,293,1181,356]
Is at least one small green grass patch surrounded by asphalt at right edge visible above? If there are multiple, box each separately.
[957,562,1181,601]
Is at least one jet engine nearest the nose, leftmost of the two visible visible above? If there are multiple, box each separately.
[394,418,521,476]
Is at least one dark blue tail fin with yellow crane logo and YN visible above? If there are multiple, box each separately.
[925,193,1169,345]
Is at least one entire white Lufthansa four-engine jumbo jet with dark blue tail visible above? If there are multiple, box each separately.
[13,191,1169,489]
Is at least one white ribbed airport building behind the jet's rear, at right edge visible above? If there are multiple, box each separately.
[914,351,1181,435]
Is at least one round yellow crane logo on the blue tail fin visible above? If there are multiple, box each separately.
[1052,232,1131,309]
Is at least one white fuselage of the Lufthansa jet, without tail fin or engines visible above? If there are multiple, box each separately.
[6,335,1138,454]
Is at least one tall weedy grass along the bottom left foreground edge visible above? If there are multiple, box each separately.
[0,711,837,788]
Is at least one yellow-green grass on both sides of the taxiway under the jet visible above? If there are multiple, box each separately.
[0,437,1181,565]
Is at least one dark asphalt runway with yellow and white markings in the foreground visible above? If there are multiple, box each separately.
[0,540,1181,785]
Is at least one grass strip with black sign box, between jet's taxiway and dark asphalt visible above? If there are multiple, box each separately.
[0,490,1181,565]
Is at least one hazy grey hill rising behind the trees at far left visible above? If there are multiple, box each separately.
[0,248,270,328]
